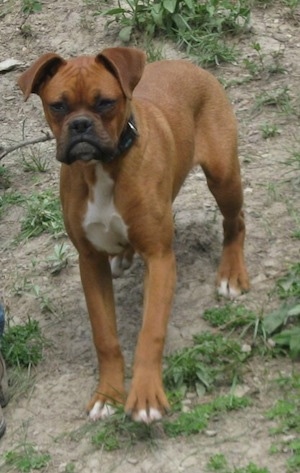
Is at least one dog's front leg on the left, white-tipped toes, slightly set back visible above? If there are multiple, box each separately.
[79,251,125,420]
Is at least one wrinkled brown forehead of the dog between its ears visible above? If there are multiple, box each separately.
[41,57,122,104]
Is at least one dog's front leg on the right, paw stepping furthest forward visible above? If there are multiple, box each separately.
[125,250,176,423]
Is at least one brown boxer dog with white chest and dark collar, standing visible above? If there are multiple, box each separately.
[19,48,249,422]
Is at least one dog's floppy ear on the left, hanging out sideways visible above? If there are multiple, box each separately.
[18,53,66,102]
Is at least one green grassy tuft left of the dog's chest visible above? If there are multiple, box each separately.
[19,190,64,239]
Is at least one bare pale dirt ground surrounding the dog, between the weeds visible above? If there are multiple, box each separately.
[0,0,300,473]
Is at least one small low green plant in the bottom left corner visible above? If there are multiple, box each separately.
[3,443,51,473]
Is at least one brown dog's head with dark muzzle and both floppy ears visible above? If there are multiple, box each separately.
[18,48,145,164]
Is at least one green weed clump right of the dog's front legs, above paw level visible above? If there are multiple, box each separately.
[164,332,249,389]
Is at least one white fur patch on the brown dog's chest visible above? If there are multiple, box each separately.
[83,163,128,254]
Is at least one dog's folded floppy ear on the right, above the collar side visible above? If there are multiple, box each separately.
[96,48,146,99]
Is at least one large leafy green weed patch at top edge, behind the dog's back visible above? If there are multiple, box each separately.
[104,0,250,63]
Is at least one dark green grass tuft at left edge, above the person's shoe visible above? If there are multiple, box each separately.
[1,319,46,367]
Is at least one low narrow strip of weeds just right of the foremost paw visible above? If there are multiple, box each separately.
[163,395,250,437]
